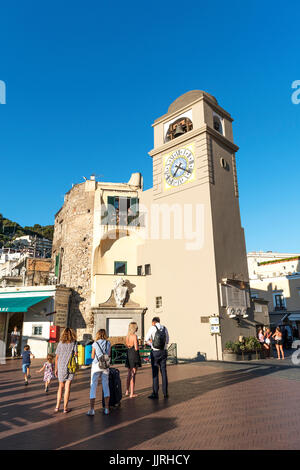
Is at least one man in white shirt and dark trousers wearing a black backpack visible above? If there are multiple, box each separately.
[145,317,169,400]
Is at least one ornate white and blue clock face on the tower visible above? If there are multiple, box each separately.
[164,145,195,188]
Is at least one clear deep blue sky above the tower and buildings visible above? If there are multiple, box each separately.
[0,0,300,252]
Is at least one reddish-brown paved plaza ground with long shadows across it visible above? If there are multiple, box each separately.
[0,358,300,450]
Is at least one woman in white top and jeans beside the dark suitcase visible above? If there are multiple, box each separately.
[87,329,111,416]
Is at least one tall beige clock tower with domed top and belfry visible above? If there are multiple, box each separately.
[141,90,255,359]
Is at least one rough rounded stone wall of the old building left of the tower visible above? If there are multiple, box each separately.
[52,180,96,337]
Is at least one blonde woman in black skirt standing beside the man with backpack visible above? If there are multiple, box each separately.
[125,322,142,398]
